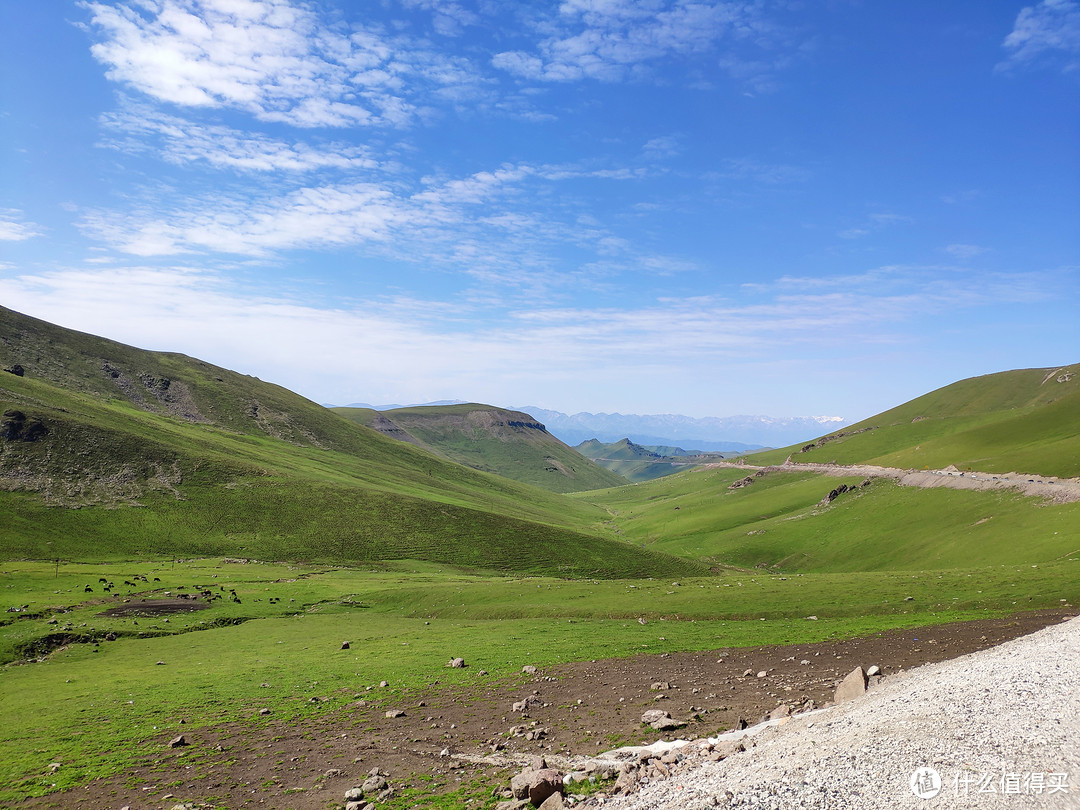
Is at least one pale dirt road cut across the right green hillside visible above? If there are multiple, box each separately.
[704,459,1080,503]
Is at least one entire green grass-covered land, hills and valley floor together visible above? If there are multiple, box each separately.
[0,309,1080,810]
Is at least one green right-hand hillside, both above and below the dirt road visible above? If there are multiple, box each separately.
[585,366,1080,571]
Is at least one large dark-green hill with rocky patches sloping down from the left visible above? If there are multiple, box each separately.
[0,310,705,577]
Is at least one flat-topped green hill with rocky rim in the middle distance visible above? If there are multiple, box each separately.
[333,404,625,492]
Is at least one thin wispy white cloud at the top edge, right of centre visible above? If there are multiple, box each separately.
[492,0,783,82]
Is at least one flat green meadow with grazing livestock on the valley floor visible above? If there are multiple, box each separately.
[0,553,1080,804]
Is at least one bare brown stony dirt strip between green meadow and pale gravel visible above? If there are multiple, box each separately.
[23,609,1076,810]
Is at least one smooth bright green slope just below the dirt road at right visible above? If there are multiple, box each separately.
[583,469,1080,572]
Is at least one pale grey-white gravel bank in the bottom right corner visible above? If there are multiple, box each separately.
[604,618,1080,810]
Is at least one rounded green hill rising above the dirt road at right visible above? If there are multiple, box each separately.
[747,365,1080,477]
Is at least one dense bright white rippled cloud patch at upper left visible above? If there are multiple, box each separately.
[83,0,488,127]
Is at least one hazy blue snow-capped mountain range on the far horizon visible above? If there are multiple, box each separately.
[339,400,851,454]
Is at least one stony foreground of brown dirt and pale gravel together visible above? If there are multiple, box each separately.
[24,610,1080,810]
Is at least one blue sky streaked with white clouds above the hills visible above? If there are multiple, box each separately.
[0,0,1080,419]
